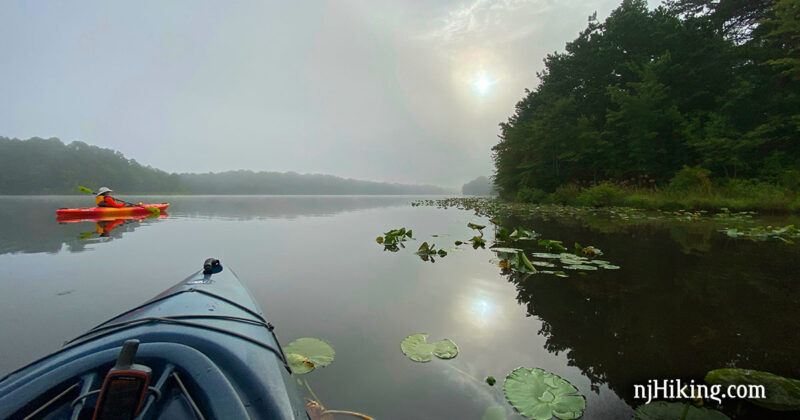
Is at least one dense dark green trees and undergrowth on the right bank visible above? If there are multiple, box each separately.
[493,0,800,211]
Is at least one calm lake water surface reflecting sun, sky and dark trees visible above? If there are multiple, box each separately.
[0,196,800,419]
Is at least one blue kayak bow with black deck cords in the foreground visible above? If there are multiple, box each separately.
[0,259,309,420]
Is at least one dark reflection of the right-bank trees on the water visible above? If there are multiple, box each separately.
[506,220,800,406]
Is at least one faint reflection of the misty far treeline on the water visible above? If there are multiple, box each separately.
[0,196,410,255]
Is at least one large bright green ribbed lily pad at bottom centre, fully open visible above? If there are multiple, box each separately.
[503,367,586,420]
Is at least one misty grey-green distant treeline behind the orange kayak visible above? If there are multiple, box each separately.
[0,137,448,195]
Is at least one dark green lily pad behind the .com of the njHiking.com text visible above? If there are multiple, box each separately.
[706,369,800,411]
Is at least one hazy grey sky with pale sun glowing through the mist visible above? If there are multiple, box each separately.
[0,0,658,186]
